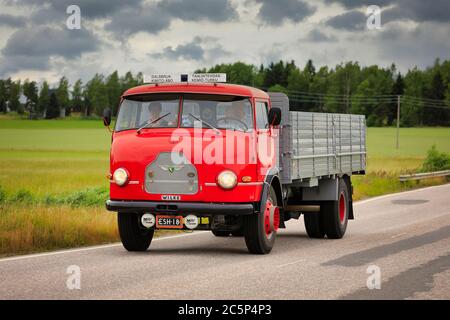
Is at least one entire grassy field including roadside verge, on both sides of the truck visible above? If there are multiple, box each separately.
[0,119,450,255]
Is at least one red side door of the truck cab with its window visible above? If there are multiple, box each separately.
[255,100,276,181]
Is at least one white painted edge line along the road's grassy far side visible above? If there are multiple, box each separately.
[0,184,450,267]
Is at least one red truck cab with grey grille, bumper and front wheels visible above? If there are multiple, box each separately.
[104,74,364,254]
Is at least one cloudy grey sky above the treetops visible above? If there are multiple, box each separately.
[0,0,450,83]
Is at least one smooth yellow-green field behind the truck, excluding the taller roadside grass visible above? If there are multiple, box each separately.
[0,120,450,195]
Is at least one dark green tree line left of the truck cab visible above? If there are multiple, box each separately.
[0,71,143,119]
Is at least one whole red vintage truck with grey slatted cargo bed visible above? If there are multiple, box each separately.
[104,74,366,254]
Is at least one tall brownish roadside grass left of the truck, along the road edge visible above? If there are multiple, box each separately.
[0,203,119,256]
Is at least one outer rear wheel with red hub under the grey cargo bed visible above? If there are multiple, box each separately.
[323,178,350,239]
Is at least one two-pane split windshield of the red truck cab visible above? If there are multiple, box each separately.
[115,94,253,132]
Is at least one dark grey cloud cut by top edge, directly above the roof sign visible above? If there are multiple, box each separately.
[158,0,238,22]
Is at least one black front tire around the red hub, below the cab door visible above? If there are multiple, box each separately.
[243,187,277,254]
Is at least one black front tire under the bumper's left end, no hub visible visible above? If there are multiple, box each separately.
[117,212,154,251]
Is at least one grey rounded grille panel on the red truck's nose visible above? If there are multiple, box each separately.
[145,152,198,194]
